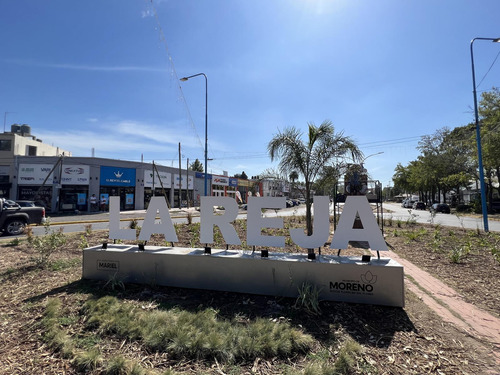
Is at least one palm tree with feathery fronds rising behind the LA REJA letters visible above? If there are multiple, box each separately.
[267,120,363,259]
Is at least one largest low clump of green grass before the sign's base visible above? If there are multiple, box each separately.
[82,296,313,363]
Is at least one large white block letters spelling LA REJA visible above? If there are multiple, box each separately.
[109,196,387,254]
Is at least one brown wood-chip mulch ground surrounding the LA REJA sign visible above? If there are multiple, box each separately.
[0,223,498,374]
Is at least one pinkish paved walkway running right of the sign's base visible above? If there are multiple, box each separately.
[374,251,500,366]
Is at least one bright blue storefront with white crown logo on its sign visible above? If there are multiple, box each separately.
[99,166,136,211]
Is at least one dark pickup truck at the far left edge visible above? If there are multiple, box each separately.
[0,198,45,236]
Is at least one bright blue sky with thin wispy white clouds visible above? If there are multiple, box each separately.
[0,0,500,186]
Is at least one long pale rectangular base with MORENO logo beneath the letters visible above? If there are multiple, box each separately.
[83,244,404,307]
